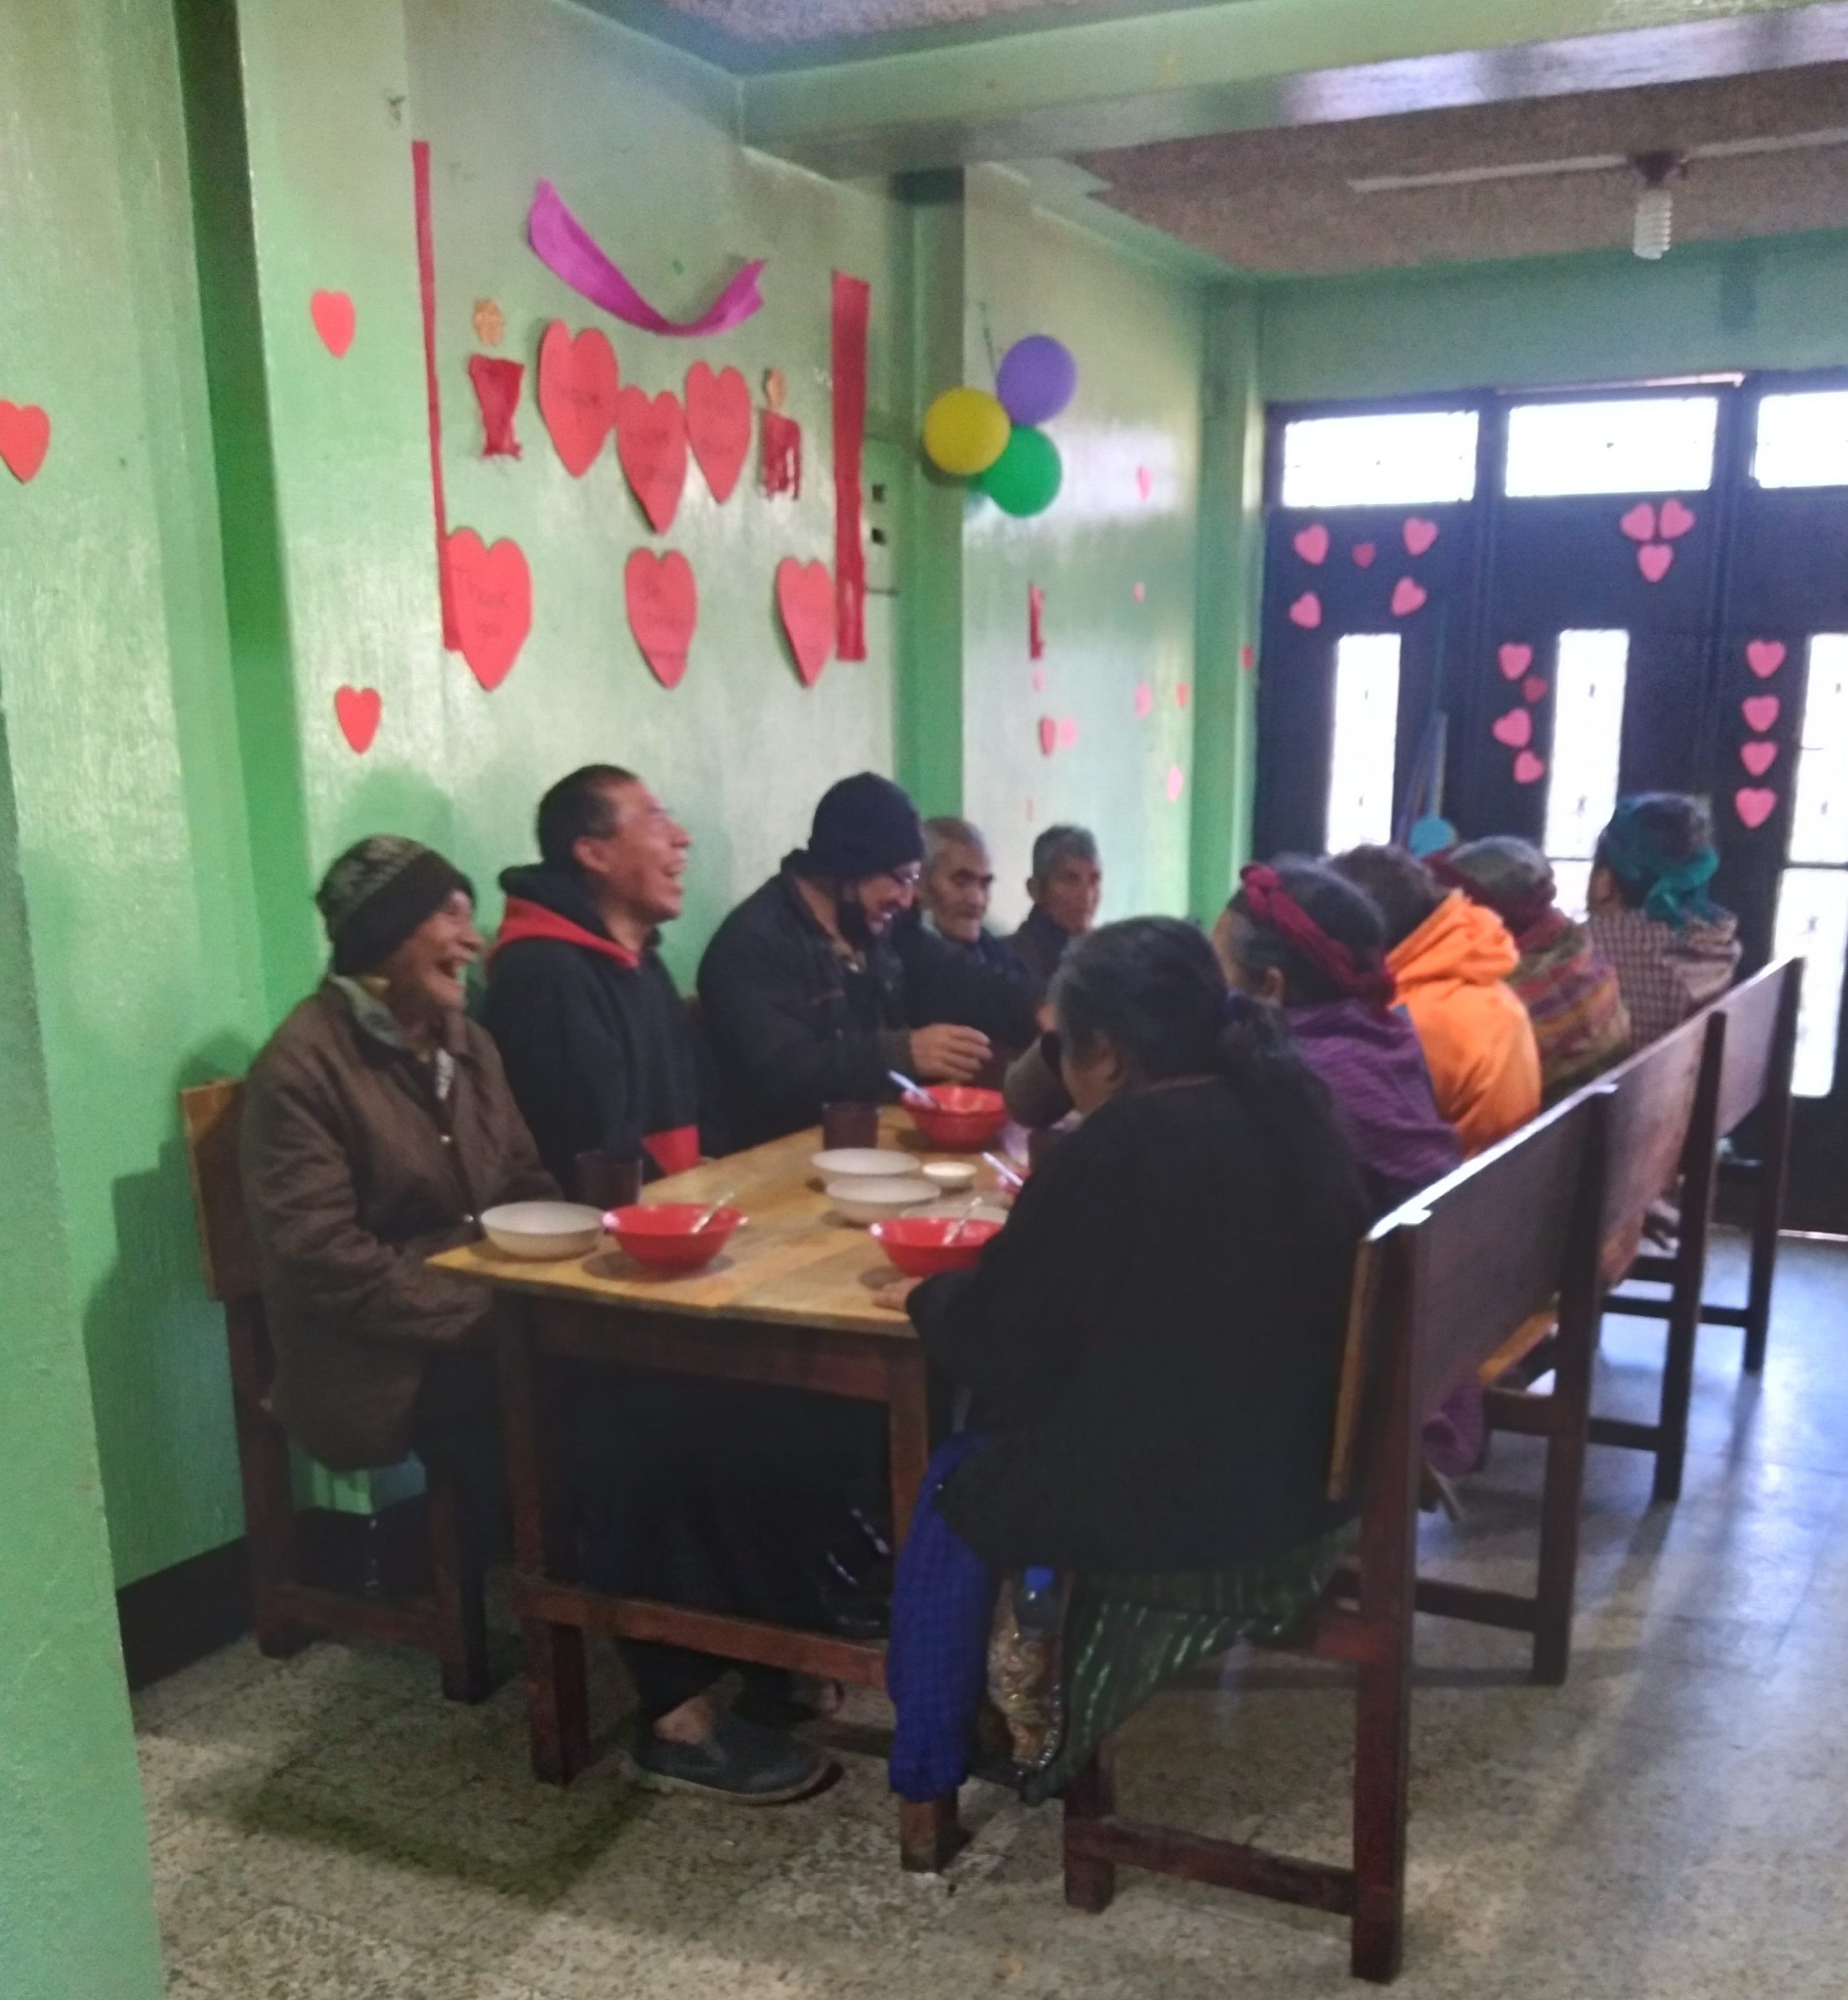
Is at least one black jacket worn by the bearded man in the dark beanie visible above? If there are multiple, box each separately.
[700,862,1036,1146]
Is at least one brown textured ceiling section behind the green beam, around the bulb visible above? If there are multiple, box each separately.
[1080,64,1848,274]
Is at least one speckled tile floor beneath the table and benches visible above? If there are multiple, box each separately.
[136,1242,1848,2000]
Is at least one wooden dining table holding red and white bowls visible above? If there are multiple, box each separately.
[432,1108,1012,1870]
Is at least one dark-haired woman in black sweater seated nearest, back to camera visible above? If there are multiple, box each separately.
[882,918,1366,1798]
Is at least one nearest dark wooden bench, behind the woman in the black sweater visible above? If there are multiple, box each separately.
[1064,1090,1612,1980]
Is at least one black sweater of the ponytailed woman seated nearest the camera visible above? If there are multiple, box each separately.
[910,1082,1360,1570]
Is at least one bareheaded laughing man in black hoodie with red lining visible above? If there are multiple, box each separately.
[484,764,720,1188]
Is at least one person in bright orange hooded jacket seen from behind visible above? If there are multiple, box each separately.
[1334,846,1540,1158]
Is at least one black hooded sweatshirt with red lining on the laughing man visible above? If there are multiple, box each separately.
[482,868,720,1188]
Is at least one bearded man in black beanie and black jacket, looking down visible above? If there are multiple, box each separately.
[700,770,1038,1146]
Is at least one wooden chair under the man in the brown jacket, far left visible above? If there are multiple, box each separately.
[180,1080,488,1702]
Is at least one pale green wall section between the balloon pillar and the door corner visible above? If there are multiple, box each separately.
[960,168,1204,926]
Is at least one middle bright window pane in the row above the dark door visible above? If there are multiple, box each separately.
[1502,396,1720,500]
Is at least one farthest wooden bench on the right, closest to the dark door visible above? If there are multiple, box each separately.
[1592,958,1802,1500]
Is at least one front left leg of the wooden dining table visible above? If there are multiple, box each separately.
[496,1300,590,1784]
